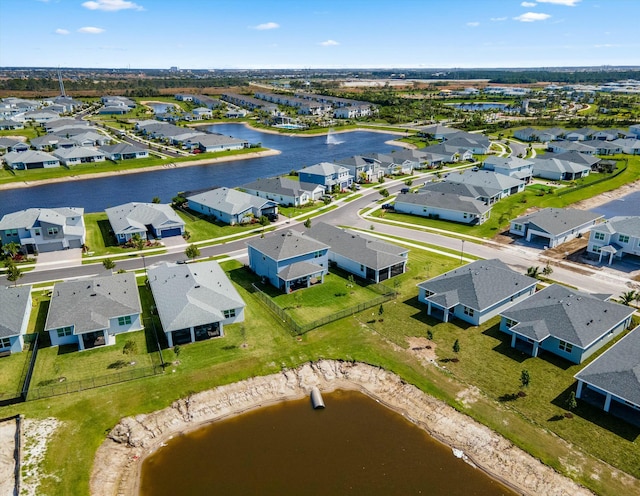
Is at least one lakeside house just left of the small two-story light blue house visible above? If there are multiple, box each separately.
[240,177,324,207]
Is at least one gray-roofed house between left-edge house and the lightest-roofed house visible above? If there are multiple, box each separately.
[44,273,143,351]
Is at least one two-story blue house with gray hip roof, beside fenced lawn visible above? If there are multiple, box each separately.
[247,229,329,293]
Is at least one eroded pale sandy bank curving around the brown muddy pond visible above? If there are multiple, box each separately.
[91,361,592,496]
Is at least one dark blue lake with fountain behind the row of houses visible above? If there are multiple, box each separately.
[0,124,399,217]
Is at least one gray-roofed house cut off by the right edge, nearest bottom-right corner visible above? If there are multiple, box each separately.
[574,329,640,426]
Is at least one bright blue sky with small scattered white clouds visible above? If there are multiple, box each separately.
[0,0,640,69]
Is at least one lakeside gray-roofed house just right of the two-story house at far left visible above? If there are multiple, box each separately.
[105,202,184,244]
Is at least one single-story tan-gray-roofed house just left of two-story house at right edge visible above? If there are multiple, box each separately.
[509,208,604,248]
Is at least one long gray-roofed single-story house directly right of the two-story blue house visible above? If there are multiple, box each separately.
[305,222,409,282]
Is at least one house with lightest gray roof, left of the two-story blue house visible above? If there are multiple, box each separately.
[148,261,246,347]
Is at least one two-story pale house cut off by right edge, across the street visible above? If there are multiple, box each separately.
[587,216,640,265]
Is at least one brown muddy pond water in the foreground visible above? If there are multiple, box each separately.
[140,391,516,496]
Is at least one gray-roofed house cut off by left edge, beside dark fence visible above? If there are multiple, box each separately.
[0,286,31,353]
